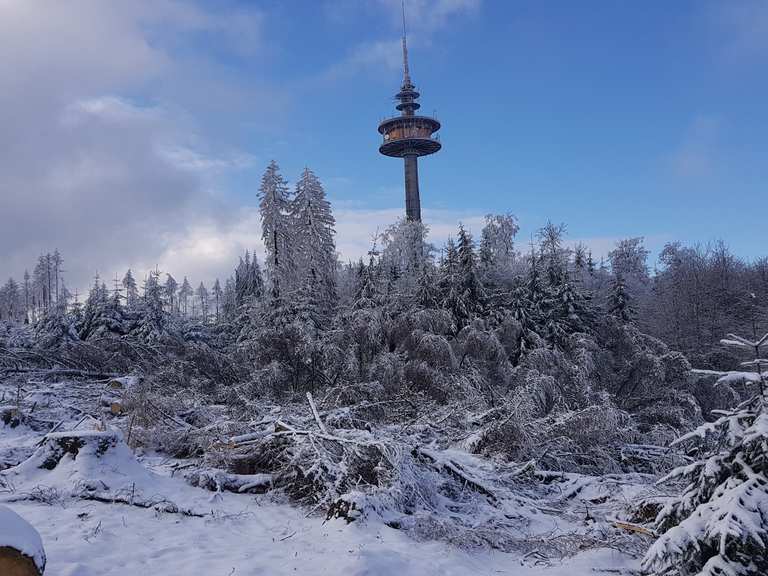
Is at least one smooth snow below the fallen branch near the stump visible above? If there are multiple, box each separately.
[4,495,633,576]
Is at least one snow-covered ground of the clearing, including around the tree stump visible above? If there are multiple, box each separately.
[0,384,648,576]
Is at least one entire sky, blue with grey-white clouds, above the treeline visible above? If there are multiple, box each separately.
[0,0,768,282]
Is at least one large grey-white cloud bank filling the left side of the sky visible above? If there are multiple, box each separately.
[0,0,266,288]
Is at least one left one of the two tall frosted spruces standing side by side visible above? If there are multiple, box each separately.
[259,160,292,294]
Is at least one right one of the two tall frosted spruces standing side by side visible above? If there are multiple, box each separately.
[290,168,337,310]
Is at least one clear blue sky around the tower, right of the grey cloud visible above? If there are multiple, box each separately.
[196,0,768,257]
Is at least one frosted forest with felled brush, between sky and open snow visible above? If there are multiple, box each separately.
[0,162,768,575]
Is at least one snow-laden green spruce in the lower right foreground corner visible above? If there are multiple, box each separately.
[643,334,768,576]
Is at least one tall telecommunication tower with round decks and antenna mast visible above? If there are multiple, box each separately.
[379,3,442,222]
